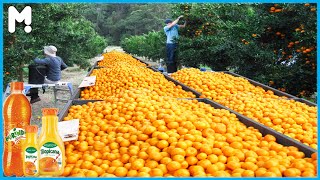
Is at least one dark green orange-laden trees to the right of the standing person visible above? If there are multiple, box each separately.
[124,3,316,96]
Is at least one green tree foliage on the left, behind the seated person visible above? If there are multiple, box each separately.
[4,4,106,84]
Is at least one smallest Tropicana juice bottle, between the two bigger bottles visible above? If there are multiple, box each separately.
[23,126,39,176]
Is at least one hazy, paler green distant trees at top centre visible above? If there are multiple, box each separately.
[84,3,172,44]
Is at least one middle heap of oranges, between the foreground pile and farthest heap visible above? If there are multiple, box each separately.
[80,63,195,99]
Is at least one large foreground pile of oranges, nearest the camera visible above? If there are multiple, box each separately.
[63,89,317,177]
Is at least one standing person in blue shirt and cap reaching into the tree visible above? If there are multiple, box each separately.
[163,16,187,73]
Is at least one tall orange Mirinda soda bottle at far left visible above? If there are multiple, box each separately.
[3,82,31,176]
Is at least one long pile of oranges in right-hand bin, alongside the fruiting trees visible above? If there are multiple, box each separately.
[171,68,317,149]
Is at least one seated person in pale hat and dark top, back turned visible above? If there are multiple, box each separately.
[30,46,67,104]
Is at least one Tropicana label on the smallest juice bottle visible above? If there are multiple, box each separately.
[24,147,39,175]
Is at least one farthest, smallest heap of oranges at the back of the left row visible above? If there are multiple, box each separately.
[98,51,147,67]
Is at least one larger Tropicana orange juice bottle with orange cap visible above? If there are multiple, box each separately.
[39,108,65,176]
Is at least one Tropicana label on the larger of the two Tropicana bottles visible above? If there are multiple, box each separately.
[39,142,62,172]
